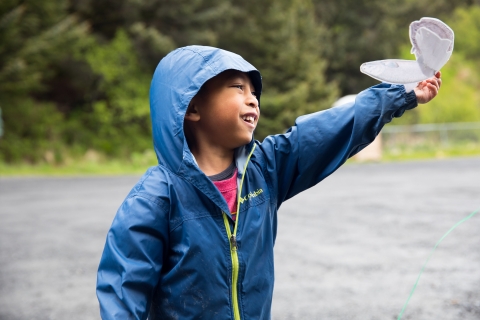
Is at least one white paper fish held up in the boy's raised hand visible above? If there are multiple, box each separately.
[360,18,454,84]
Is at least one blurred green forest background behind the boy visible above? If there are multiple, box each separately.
[0,0,480,172]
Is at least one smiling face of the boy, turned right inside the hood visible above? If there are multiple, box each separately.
[185,70,260,150]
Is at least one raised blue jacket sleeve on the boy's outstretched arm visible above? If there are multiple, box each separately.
[258,83,417,207]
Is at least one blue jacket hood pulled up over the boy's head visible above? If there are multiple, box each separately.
[150,46,262,173]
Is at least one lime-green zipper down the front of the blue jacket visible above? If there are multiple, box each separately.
[223,144,256,320]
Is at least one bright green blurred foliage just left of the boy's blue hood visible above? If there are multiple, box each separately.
[77,29,151,155]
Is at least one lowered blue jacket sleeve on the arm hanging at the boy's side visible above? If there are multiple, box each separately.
[97,195,168,319]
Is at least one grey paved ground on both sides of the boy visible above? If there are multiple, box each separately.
[0,158,480,320]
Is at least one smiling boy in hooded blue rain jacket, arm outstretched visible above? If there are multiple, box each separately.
[97,46,441,320]
